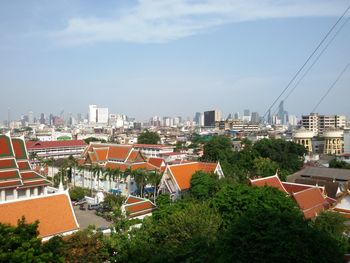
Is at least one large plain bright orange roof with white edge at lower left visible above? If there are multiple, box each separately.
[0,192,79,237]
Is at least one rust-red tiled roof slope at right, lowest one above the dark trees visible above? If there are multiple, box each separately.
[292,187,329,219]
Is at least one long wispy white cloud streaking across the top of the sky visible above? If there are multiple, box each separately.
[51,0,345,45]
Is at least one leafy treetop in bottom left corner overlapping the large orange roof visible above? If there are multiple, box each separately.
[0,218,64,262]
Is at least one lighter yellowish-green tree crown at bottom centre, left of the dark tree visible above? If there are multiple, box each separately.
[112,202,220,262]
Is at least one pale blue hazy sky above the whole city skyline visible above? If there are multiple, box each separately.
[0,0,350,120]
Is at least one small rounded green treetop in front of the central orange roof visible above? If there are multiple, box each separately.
[190,171,218,200]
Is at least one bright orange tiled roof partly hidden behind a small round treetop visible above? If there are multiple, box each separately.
[168,162,217,190]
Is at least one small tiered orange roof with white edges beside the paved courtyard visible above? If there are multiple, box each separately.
[123,195,156,218]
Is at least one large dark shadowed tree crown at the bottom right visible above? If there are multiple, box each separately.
[218,206,344,263]
